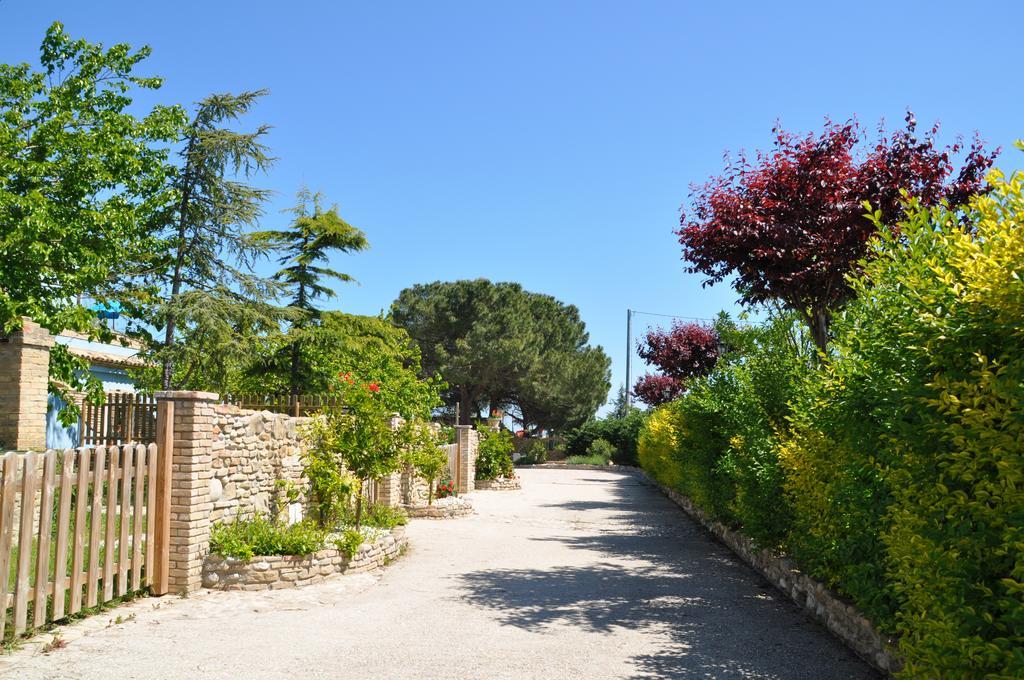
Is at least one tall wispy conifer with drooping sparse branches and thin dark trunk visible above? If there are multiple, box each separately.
[135,90,275,389]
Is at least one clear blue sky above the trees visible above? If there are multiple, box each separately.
[0,0,1024,409]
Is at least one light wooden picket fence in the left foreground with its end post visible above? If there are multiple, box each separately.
[0,438,172,639]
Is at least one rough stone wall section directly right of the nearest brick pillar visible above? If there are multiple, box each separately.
[210,405,309,521]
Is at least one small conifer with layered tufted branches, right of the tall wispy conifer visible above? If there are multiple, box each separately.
[254,189,370,395]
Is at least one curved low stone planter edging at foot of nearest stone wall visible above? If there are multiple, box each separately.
[203,526,409,590]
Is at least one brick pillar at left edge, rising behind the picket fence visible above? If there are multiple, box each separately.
[0,318,53,451]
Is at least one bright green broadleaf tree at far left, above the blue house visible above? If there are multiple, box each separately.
[0,23,185,409]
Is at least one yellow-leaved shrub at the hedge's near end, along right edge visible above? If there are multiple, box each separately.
[884,166,1024,678]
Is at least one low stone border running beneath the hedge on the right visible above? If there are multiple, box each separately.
[635,468,903,674]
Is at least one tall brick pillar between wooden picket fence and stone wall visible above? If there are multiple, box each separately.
[157,391,220,593]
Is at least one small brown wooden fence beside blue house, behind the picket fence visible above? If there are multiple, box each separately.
[79,392,157,447]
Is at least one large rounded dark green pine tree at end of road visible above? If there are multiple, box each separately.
[391,279,610,429]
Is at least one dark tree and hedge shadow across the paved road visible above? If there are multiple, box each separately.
[458,475,879,679]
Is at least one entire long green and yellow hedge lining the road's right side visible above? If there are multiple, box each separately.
[639,166,1024,678]
